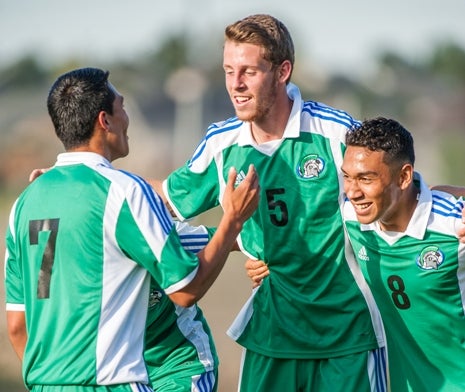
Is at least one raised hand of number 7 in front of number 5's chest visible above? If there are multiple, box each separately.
[222,165,260,225]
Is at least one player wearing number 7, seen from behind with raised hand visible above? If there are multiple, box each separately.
[5,68,259,392]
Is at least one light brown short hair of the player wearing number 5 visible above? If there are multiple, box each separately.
[224,14,294,82]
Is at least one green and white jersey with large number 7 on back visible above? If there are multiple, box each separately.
[5,153,198,386]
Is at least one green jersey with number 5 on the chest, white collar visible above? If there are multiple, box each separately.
[163,84,383,358]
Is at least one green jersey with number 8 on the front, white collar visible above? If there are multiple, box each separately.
[344,173,465,392]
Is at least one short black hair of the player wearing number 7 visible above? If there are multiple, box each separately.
[47,68,115,150]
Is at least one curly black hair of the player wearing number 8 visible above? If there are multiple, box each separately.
[346,117,415,165]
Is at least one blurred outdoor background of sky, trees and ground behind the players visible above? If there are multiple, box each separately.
[0,0,465,392]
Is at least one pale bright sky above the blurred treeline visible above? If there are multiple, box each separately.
[0,0,465,74]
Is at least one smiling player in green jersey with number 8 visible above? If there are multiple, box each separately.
[342,118,465,392]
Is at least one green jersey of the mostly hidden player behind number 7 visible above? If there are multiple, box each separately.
[144,222,218,390]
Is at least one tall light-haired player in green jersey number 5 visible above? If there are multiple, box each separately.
[152,15,386,392]
